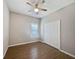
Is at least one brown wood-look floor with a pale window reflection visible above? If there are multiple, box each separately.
[4,42,75,59]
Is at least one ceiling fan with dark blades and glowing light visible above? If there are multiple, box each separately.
[26,0,47,14]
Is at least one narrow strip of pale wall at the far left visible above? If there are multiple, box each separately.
[3,1,9,55]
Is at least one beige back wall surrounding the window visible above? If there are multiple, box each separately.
[9,12,40,45]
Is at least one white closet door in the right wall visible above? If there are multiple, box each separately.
[44,21,60,49]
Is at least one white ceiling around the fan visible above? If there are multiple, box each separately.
[6,0,74,18]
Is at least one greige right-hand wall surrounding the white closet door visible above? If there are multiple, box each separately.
[41,3,75,55]
